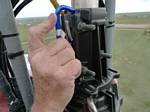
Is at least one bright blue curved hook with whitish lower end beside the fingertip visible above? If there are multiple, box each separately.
[55,5,75,38]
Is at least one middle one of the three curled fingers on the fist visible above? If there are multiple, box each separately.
[55,48,75,66]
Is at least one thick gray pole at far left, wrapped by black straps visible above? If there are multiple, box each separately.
[0,0,33,112]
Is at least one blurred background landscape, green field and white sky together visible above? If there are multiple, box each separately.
[16,0,150,112]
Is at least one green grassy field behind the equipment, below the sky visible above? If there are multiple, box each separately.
[18,11,150,112]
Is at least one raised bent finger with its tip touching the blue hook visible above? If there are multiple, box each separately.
[28,14,56,52]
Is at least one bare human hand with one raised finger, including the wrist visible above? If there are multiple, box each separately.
[28,14,81,112]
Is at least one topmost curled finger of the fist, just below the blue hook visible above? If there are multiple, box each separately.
[47,38,72,56]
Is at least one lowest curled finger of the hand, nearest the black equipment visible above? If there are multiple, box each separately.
[63,59,81,78]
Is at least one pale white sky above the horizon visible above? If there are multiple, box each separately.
[17,0,150,18]
